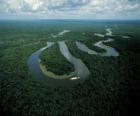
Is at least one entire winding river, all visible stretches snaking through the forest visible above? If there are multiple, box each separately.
[28,28,119,86]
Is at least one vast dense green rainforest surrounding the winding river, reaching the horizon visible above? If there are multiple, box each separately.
[0,21,140,116]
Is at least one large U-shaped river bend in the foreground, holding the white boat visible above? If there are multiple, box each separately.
[28,41,90,86]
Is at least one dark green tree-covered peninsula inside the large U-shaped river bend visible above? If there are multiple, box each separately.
[40,44,74,75]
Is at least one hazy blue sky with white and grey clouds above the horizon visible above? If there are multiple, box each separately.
[0,0,140,19]
